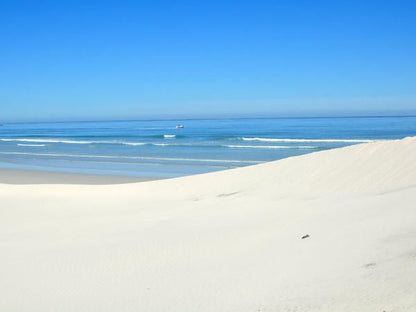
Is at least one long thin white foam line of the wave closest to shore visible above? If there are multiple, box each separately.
[0,152,261,164]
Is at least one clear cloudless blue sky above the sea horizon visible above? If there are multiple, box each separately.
[0,0,416,121]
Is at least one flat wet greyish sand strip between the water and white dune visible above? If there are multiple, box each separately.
[0,168,164,185]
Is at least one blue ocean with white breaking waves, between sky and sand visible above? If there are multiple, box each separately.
[0,117,416,177]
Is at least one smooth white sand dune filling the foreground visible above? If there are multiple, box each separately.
[0,138,416,312]
